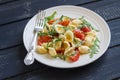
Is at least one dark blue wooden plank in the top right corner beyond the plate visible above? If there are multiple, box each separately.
[83,0,120,20]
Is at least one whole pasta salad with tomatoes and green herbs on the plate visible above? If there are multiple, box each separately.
[36,12,100,62]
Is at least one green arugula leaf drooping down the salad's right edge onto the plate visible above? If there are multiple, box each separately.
[90,38,100,58]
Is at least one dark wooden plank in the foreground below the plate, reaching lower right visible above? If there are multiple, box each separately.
[8,46,120,80]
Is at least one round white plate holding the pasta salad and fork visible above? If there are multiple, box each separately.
[23,5,111,68]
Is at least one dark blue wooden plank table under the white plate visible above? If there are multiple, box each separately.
[0,0,120,80]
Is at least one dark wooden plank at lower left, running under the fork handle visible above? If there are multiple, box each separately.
[0,46,46,80]
